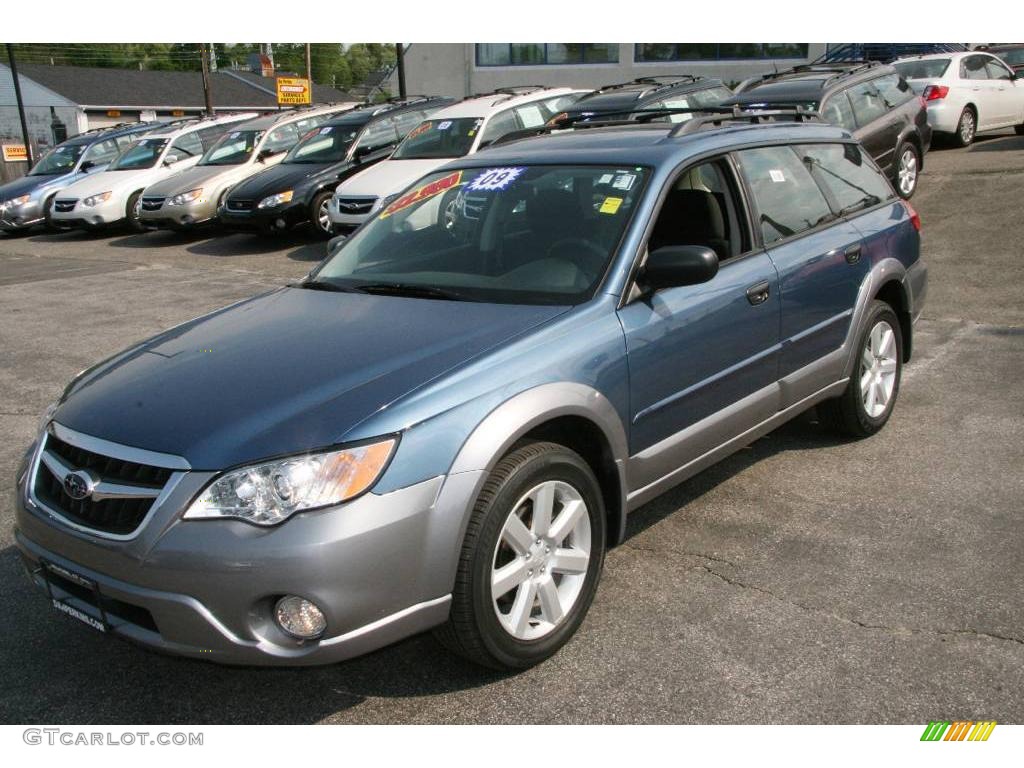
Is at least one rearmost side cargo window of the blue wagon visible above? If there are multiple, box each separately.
[796,144,895,214]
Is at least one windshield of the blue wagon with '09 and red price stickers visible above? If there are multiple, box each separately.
[312,166,648,305]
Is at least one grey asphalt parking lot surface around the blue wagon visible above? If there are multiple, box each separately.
[0,133,1024,724]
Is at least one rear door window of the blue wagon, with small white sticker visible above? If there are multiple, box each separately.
[737,146,834,245]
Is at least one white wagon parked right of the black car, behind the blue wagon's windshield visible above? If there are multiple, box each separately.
[328,87,590,233]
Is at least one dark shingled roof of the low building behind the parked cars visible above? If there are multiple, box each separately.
[9,65,353,109]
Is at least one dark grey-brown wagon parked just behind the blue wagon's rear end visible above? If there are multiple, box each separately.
[724,61,932,199]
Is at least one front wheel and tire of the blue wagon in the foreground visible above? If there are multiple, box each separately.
[435,442,605,670]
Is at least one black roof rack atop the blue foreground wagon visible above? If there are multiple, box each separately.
[488,104,820,146]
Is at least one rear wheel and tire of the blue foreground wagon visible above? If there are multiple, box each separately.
[818,300,903,438]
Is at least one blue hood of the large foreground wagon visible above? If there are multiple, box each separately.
[54,288,565,470]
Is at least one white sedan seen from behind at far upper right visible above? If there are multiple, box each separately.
[893,51,1024,146]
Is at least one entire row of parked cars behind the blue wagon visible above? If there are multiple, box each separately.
[0,49,1024,237]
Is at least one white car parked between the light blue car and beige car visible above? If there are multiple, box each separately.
[49,112,256,231]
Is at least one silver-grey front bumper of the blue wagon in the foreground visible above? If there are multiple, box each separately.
[15,438,456,665]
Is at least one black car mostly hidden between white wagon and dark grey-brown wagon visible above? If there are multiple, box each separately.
[554,75,732,122]
